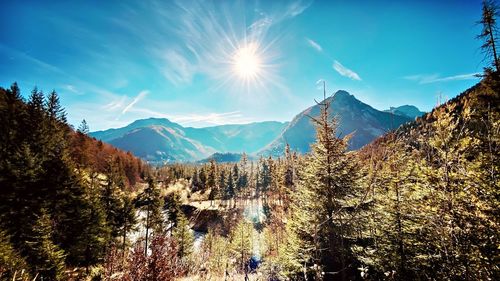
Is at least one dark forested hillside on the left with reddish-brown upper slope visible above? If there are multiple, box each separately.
[0,84,149,280]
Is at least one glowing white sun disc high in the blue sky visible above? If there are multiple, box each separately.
[233,44,262,80]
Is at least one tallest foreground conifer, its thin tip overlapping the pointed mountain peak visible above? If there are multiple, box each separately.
[290,86,357,280]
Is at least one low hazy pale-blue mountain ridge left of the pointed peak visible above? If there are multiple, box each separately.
[91,118,287,163]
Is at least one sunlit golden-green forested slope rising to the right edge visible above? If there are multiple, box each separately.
[356,73,500,280]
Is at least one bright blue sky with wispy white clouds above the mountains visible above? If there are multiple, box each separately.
[0,0,484,130]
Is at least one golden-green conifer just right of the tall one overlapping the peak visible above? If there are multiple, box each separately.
[356,141,431,280]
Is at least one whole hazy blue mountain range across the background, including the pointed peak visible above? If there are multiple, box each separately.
[90,90,423,164]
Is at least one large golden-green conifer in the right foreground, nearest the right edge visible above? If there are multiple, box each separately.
[421,101,499,280]
